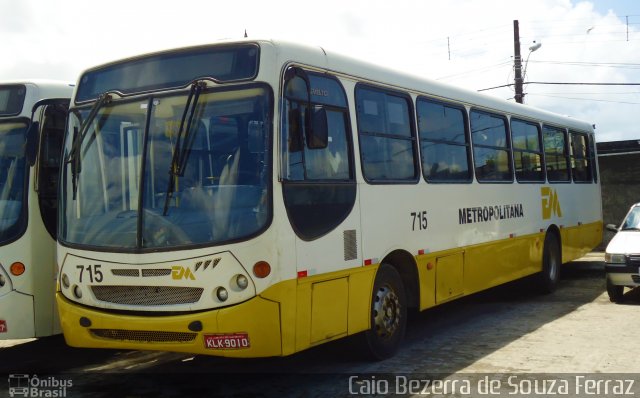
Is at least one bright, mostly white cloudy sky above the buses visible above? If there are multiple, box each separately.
[0,0,640,142]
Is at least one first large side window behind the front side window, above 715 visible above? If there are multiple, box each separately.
[356,86,419,182]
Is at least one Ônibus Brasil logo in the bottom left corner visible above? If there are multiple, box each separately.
[9,374,73,398]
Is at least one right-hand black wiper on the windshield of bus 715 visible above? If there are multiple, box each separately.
[162,80,206,216]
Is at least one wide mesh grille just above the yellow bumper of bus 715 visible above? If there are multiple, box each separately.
[91,285,204,305]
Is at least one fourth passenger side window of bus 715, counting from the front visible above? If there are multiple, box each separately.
[511,119,545,182]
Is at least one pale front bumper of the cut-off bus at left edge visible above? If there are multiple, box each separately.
[0,290,36,340]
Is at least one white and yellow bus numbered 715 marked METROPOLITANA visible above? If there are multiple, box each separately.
[57,40,602,358]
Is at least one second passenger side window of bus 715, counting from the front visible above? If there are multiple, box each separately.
[417,98,472,182]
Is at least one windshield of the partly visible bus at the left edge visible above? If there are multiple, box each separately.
[0,120,28,243]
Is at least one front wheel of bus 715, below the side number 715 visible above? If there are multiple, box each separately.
[363,263,407,361]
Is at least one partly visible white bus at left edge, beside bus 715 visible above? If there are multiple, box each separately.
[0,80,73,339]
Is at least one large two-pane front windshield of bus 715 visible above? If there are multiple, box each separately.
[59,84,272,251]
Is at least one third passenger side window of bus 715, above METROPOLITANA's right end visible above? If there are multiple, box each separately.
[471,110,513,182]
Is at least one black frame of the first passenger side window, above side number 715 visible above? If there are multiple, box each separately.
[354,82,421,185]
